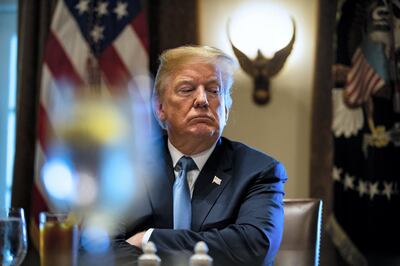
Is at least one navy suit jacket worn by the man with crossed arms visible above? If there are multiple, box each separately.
[109,137,287,266]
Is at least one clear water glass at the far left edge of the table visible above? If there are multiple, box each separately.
[0,208,28,266]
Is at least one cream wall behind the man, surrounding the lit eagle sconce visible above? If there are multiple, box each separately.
[198,0,318,197]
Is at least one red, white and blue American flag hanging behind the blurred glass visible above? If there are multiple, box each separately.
[30,0,151,248]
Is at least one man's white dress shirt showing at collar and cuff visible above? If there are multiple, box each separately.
[142,139,217,247]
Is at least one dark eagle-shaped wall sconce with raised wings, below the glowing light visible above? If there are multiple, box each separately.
[227,18,296,105]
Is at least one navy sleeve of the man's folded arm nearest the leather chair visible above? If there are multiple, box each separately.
[150,163,287,265]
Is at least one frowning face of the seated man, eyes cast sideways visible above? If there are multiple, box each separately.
[158,61,228,150]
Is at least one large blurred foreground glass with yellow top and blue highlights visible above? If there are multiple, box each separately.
[41,96,157,253]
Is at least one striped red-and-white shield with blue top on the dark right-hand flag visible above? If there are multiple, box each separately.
[344,40,388,107]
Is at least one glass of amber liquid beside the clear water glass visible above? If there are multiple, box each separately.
[39,212,79,266]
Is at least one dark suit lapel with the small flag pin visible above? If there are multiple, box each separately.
[192,138,232,231]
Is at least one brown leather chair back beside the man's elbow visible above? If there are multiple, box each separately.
[274,199,322,266]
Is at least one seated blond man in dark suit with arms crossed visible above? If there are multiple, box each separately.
[114,46,287,266]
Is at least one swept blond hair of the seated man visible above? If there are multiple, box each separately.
[153,46,236,128]
